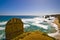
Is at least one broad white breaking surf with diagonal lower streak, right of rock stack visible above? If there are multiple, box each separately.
[22,17,55,29]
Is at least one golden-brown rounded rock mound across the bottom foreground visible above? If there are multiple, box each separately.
[12,31,55,40]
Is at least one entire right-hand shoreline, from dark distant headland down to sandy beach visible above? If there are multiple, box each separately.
[45,14,60,40]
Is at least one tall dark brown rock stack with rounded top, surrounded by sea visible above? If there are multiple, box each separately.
[5,18,24,40]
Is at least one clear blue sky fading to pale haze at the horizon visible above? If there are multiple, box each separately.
[0,0,60,15]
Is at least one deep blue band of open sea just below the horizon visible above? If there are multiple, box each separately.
[0,16,37,22]
